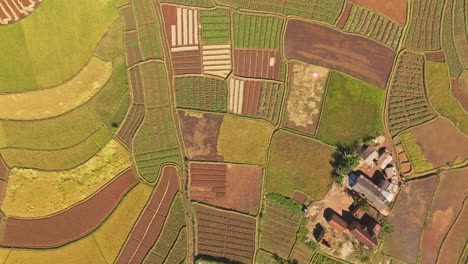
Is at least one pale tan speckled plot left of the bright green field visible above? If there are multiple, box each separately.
[284,62,329,135]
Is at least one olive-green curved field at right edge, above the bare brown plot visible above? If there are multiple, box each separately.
[426,62,468,135]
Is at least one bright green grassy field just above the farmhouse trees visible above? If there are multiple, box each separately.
[317,72,385,144]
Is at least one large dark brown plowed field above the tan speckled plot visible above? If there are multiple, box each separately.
[284,19,395,89]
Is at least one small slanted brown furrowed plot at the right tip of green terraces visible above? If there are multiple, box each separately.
[117,104,145,146]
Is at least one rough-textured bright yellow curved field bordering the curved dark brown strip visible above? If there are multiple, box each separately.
[2,140,132,217]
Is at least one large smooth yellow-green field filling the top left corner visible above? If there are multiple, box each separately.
[0,0,119,93]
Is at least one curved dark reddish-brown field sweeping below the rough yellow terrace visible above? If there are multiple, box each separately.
[1,170,138,247]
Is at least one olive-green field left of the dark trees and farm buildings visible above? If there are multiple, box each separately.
[265,131,334,200]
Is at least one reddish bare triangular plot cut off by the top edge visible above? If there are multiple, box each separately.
[350,0,407,26]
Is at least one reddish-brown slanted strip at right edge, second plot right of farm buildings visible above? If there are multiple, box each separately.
[421,168,468,263]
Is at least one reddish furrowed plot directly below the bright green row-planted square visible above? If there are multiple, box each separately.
[234,49,281,80]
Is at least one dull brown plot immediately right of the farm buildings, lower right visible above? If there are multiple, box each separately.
[383,176,438,263]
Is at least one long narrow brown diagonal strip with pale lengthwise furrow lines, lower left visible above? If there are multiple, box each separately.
[116,166,180,264]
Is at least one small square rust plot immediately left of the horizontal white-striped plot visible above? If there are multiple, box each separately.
[172,49,202,74]
